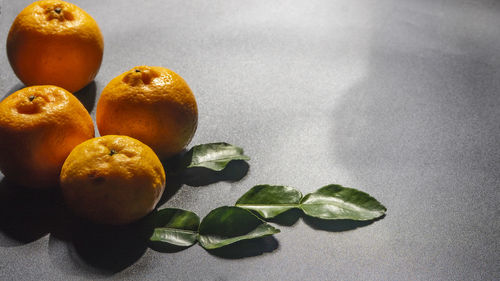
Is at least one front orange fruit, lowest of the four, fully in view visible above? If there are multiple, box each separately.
[61,135,165,225]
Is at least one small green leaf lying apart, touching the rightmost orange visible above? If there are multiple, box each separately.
[185,142,250,171]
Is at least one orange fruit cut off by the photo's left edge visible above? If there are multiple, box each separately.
[0,86,94,188]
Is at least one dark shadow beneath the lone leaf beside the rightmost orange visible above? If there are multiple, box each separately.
[182,160,250,186]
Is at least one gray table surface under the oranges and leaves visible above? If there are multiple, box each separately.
[0,0,500,280]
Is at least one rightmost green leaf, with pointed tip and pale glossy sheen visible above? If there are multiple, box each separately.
[300,184,387,220]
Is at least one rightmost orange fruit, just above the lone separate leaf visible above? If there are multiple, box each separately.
[96,66,198,158]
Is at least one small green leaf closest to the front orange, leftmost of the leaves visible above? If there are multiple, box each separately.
[149,208,200,247]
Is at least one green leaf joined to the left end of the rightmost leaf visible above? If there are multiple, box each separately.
[236,184,302,219]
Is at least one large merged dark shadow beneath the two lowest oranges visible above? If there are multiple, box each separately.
[0,178,153,273]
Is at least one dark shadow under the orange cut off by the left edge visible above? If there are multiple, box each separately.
[0,178,64,247]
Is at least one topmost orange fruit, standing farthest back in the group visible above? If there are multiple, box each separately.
[7,0,104,93]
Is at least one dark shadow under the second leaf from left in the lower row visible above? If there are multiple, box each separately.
[207,236,279,259]
